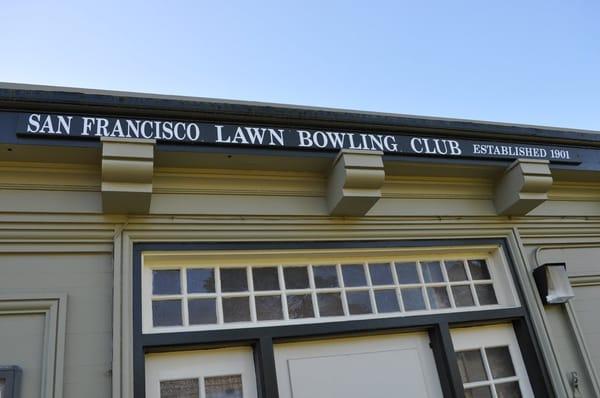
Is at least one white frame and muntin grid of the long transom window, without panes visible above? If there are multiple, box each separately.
[142,247,519,333]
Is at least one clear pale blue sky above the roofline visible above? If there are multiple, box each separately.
[0,0,600,130]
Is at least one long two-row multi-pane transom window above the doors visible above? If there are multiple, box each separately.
[144,249,514,332]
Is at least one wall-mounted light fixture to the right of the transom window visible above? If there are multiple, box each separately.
[533,263,575,304]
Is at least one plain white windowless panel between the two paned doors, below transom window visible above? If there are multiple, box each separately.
[275,333,442,398]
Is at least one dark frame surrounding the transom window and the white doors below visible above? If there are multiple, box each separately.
[132,238,555,398]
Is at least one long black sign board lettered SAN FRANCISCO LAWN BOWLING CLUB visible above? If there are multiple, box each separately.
[17,113,581,164]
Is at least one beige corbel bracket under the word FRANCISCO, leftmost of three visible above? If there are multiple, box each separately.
[102,138,156,214]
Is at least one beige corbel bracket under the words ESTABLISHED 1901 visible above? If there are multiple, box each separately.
[494,159,552,216]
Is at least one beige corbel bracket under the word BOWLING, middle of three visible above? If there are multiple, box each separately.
[327,149,385,216]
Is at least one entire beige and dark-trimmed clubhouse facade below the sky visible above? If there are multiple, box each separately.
[0,84,600,398]
